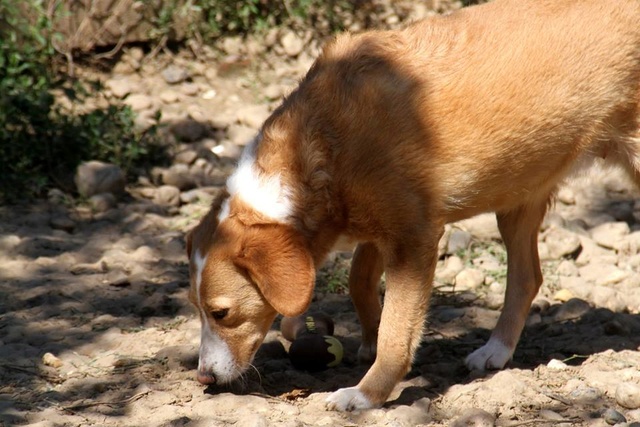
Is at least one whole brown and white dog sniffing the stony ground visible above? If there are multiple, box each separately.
[188,0,640,410]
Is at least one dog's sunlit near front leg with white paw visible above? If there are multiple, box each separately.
[327,233,441,411]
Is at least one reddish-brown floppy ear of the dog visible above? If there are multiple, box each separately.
[236,224,315,317]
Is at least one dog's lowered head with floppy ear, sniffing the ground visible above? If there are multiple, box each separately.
[187,199,315,384]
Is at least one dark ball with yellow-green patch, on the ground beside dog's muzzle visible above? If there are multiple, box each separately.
[289,334,344,371]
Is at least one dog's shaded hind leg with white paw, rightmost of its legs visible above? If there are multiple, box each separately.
[466,199,548,370]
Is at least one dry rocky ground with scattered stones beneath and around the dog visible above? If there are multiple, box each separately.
[0,2,640,427]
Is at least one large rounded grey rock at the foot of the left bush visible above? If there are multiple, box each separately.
[75,160,125,197]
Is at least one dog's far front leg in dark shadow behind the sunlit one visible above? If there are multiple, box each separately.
[349,243,383,363]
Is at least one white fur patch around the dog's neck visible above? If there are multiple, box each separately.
[218,135,293,222]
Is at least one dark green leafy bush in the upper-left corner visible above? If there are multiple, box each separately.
[0,0,168,201]
